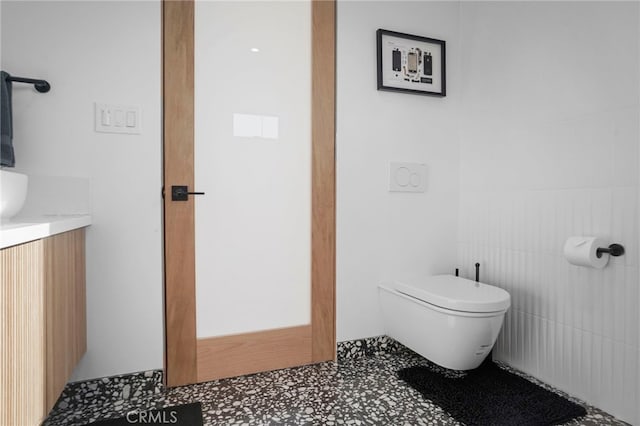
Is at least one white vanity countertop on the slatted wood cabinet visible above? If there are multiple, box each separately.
[0,215,91,250]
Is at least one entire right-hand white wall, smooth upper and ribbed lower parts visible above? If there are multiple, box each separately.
[458,2,640,424]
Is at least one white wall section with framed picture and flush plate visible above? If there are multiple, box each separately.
[336,1,460,341]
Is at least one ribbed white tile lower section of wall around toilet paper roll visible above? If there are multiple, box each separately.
[459,187,640,421]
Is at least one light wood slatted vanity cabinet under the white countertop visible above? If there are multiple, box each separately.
[0,229,87,426]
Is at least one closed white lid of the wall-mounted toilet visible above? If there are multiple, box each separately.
[394,275,511,312]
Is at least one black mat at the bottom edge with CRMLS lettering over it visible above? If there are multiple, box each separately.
[86,402,202,426]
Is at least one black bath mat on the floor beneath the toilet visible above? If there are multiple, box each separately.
[398,361,587,426]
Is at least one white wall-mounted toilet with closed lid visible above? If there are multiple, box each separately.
[379,275,511,370]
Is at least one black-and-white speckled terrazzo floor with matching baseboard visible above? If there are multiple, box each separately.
[44,337,626,426]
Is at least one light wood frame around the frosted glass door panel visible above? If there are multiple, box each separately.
[162,0,336,386]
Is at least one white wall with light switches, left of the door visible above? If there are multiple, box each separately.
[1,1,162,379]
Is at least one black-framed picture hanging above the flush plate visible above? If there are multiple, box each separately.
[376,29,447,96]
